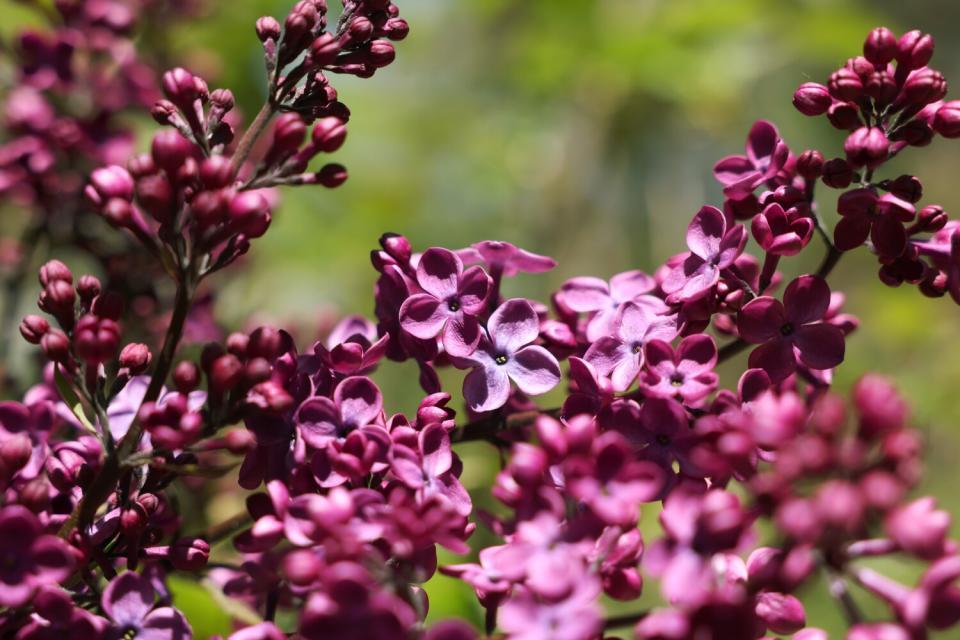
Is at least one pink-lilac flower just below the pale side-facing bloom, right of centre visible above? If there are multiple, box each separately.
[583,302,677,391]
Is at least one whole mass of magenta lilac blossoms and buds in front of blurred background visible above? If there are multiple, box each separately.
[0,13,960,640]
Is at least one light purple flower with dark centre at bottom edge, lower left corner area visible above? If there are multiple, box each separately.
[101,571,193,640]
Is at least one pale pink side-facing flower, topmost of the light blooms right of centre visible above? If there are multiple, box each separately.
[559,271,666,342]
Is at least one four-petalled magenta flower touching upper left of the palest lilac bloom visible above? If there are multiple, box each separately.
[400,247,491,357]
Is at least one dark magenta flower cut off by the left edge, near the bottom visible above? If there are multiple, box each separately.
[0,504,74,607]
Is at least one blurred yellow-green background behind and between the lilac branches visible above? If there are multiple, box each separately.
[0,0,960,637]
